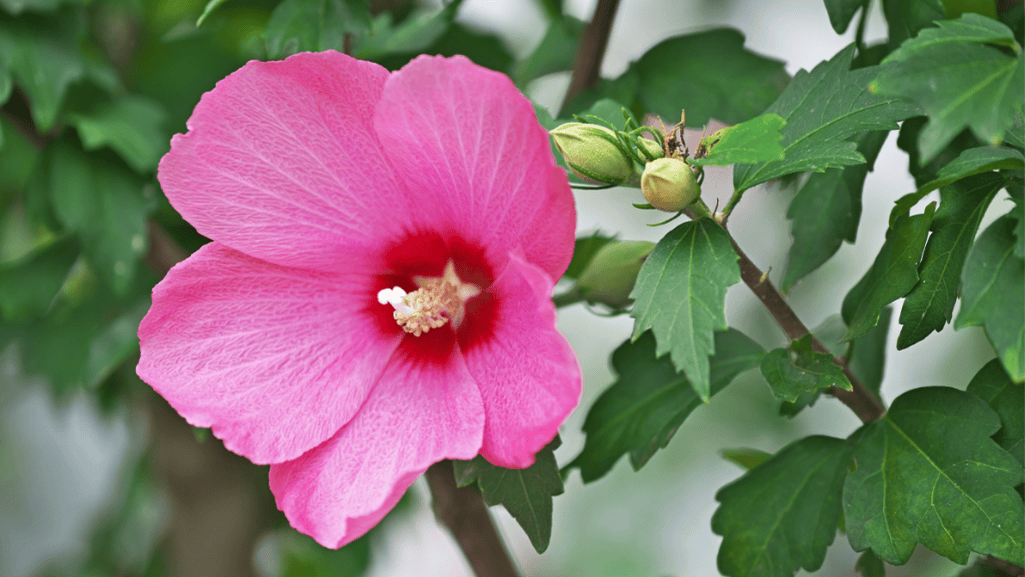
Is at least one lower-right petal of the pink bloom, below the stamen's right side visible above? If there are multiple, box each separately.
[459,253,581,468]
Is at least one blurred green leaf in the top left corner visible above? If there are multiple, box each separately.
[0,17,86,132]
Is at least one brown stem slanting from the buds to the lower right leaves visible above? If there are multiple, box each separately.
[724,234,886,422]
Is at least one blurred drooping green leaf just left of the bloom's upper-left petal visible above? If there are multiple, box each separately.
[39,142,156,295]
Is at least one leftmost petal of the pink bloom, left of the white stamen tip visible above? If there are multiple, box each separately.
[136,243,403,463]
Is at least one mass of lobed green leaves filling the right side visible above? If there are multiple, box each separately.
[553,0,1025,577]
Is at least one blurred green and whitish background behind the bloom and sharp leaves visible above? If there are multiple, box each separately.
[0,0,1008,577]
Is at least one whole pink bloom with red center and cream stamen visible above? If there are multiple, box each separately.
[137,52,581,547]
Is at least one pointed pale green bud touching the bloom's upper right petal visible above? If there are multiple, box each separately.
[549,122,637,184]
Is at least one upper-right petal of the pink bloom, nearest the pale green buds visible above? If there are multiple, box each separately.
[374,56,576,279]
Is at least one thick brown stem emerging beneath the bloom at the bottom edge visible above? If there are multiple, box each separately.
[426,461,520,577]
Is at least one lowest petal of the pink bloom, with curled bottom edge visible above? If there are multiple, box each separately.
[271,332,484,548]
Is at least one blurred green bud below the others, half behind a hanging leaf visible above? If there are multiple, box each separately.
[575,241,655,307]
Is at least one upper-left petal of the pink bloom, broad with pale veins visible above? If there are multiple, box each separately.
[158,52,409,271]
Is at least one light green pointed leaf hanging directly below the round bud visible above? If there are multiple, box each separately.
[630,218,740,401]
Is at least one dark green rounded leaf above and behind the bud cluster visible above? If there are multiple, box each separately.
[630,29,789,127]
